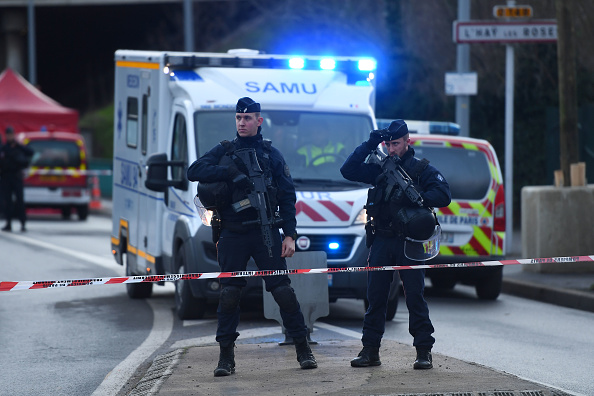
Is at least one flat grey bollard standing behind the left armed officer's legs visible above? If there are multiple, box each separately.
[262,252,330,345]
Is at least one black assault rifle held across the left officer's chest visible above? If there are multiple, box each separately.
[232,149,280,257]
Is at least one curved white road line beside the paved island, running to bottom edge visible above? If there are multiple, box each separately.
[93,300,173,396]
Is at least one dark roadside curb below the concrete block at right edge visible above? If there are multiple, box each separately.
[501,278,594,312]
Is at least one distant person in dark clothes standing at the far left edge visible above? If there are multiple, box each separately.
[0,126,33,232]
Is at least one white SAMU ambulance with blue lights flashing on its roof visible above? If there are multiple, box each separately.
[111,50,398,319]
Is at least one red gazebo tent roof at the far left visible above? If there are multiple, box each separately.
[0,69,78,136]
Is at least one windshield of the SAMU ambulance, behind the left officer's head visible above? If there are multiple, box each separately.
[194,111,373,188]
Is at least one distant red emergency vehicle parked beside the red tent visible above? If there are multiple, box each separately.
[17,131,91,220]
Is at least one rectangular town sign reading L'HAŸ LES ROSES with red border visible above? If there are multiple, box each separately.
[453,20,557,44]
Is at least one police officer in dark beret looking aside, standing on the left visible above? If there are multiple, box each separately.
[187,97,318,377]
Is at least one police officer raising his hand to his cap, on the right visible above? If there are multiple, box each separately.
[340,120,451,369]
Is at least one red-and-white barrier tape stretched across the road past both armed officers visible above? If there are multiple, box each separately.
[0,256,594,291]
